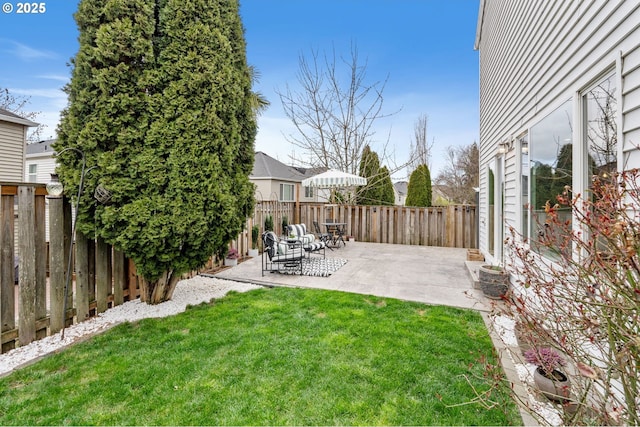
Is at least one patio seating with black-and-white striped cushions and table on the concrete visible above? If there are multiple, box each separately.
[262,221,346,276]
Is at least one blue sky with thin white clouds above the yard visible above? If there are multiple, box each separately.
[0,0,479,179]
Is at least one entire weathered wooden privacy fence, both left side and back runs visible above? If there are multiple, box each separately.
[0,183,477,352]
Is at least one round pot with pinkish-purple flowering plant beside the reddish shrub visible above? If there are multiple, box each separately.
[524,347,571,402]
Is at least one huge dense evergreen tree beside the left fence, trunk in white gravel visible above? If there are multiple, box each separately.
[56,0,256,303]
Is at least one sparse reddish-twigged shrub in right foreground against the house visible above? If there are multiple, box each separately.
[500,169,640,425]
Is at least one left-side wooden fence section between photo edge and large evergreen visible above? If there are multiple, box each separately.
[0,183,139,352]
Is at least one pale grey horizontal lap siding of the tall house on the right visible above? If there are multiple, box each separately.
[476,0,640,261]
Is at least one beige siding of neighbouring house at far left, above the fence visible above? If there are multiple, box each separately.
[0,120,26,182]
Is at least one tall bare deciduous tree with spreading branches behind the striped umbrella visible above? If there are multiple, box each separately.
[278,45,399,174]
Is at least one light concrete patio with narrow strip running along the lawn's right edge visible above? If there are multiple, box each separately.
[214,242,538,426]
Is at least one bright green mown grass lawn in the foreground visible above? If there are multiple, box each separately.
[0,288,521,425]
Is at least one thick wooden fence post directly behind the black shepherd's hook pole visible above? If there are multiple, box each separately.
[49,196,65,334]
